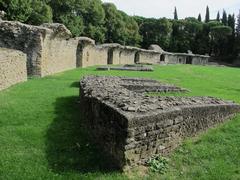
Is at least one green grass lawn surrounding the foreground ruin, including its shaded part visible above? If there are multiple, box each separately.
[0,65,240,180]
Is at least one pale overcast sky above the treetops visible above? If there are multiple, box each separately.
[103,0,240,19]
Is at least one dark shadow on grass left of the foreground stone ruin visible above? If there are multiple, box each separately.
[46,97,117,173]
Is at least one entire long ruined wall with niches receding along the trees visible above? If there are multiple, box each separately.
[0,20,209,77]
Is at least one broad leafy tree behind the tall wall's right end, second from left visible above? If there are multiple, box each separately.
[49,0,106,40]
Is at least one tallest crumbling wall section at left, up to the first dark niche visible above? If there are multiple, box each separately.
[0,21,78,77]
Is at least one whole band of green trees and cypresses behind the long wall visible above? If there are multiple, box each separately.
[0,0,240,62]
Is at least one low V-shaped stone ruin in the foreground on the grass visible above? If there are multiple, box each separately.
[80,76,240,170]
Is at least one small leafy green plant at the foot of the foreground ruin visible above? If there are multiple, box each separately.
[147,155,168,174]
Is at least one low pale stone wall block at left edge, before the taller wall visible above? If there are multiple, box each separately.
[0,48,27,90]
